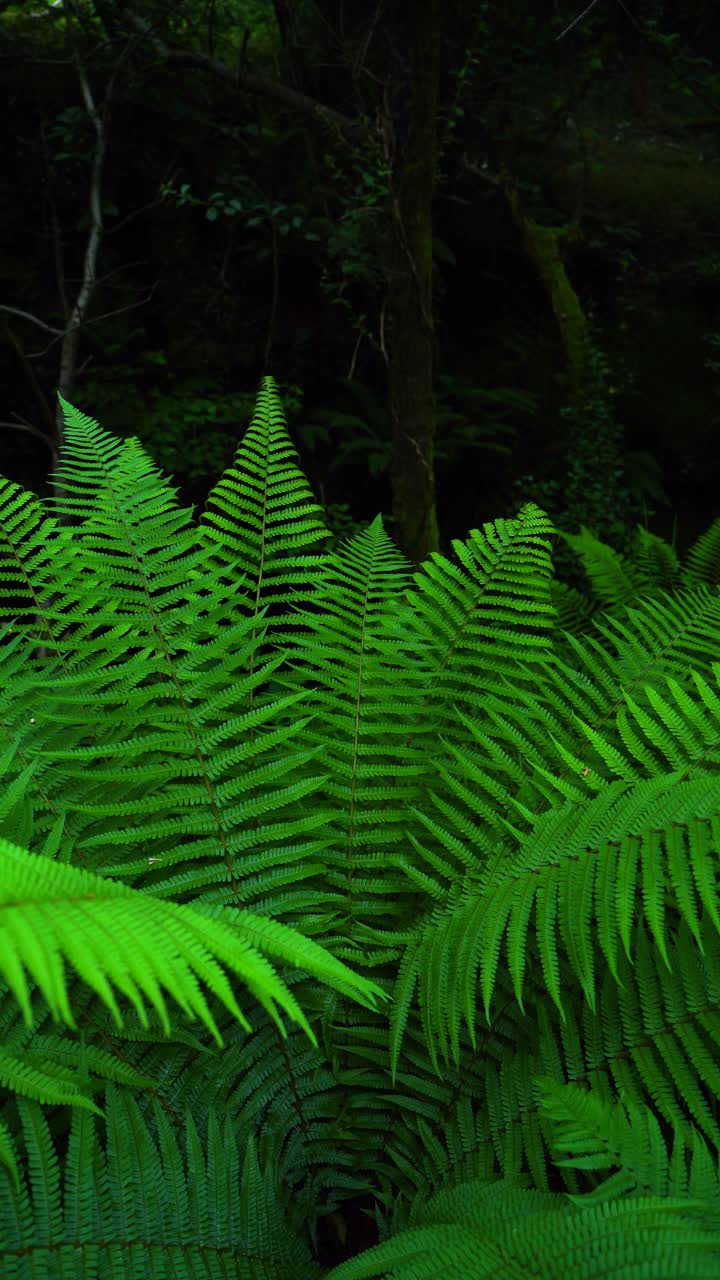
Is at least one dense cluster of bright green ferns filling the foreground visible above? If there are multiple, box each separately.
[0,379,720,1280]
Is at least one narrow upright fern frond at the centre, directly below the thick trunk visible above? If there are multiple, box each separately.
[263,516,433,965]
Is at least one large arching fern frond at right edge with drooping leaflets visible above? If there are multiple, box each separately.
[394,774,720,1069]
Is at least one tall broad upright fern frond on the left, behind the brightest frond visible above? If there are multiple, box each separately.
[0,391,363,942]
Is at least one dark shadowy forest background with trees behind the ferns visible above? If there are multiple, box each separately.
[0,0,720,579]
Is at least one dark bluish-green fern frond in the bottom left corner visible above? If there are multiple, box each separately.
[0,1085,319,1280]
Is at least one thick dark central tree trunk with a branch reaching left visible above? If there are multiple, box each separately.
[110,0,451,564]
